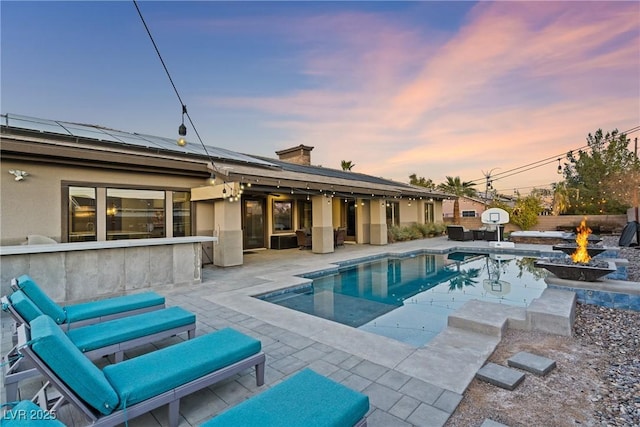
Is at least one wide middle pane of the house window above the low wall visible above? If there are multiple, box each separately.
[106,188,166,240]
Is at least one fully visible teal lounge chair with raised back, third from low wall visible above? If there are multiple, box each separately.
[18,316,265,427]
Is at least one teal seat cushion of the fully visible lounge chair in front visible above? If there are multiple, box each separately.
[103,328,261,408]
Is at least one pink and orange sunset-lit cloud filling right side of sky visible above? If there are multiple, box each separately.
[202,2,640,191]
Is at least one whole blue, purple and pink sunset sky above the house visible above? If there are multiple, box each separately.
[0,0,640,194]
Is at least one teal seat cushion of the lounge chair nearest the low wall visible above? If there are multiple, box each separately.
[64,292,164,323]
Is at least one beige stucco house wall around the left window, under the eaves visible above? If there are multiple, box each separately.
[0,160,203,245]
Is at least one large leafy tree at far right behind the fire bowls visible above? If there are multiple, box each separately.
[563,129,640,215]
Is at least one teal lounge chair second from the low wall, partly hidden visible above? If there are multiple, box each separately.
[1,291,196,401]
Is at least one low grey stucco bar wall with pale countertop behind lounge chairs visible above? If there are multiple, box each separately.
[0,237,211,303]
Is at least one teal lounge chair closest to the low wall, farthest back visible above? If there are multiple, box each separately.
[11,274,165,328]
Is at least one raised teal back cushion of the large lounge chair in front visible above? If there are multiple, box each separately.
[30,315,120,415]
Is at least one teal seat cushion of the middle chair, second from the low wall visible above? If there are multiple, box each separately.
[67,307,196,352]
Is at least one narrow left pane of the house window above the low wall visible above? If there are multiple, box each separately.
[67,187,97,242]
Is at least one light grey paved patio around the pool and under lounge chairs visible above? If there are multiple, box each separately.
[2,237,575,427]
